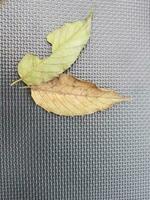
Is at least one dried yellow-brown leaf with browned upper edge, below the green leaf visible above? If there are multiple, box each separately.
[31,74,126,116]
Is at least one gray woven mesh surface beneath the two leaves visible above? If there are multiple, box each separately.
[0,0,150,200]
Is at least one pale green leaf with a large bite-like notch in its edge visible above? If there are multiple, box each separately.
[15,13,92,85]
